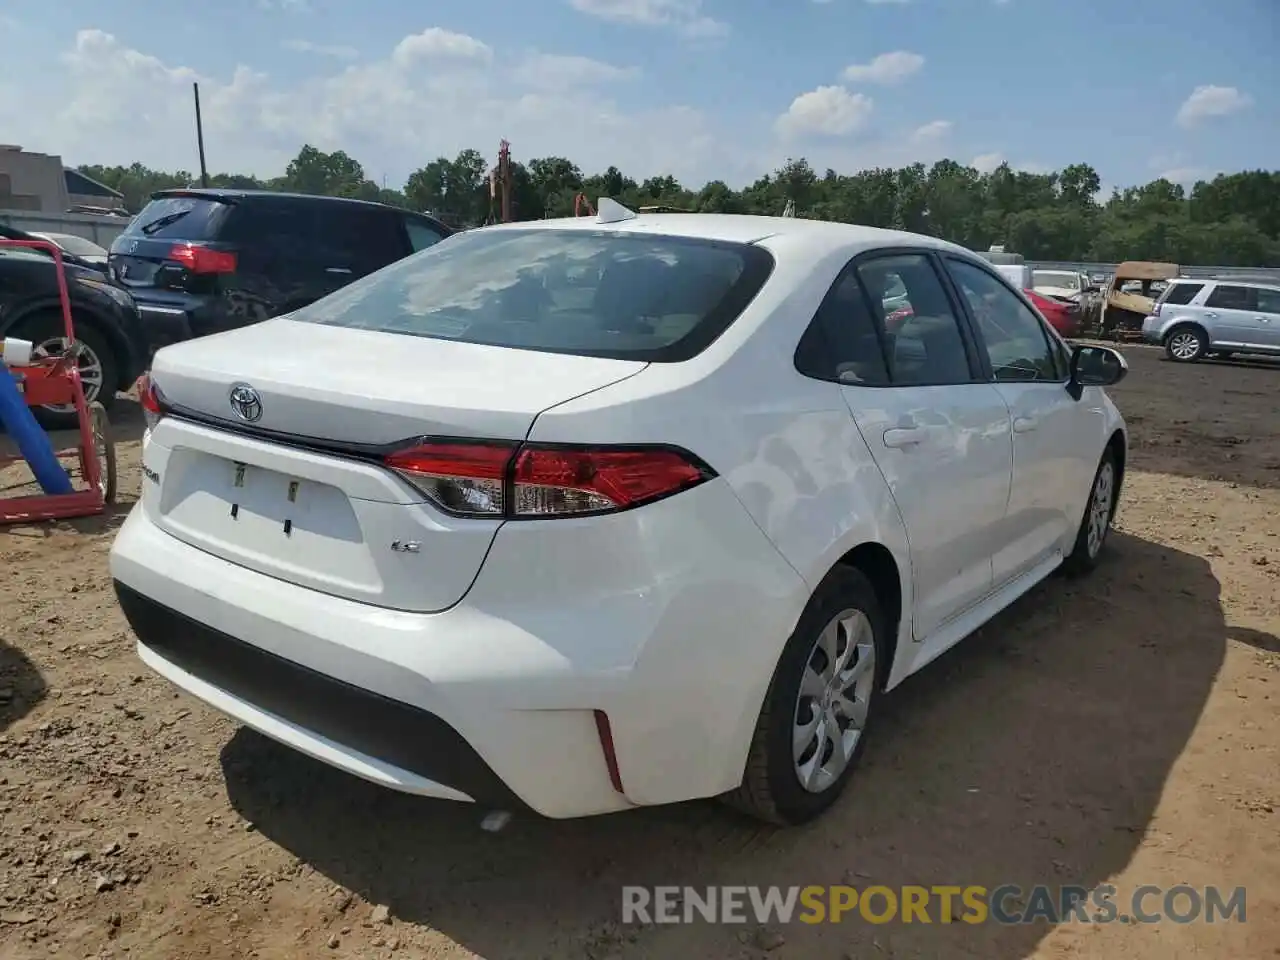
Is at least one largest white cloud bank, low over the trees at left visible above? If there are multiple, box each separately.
[22,28,742,184]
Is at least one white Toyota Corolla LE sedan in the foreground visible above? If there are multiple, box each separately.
[110,201,1126,823]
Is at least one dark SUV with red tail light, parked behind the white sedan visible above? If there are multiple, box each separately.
[108,188,453,352]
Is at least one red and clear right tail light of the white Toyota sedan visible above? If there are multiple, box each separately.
[384,440,716,520]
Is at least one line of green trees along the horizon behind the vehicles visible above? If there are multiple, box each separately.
[79,145,1280,266]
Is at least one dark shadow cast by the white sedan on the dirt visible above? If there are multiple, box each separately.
[223,532,1228,960]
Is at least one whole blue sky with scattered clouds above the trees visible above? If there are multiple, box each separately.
[0,0,1280,193]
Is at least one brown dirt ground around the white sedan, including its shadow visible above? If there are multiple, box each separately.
[0,347,1280,960]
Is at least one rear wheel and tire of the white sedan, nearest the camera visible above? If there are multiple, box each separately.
[723,567,888,826]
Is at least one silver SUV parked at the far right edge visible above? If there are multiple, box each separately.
[1142,276,1280,364]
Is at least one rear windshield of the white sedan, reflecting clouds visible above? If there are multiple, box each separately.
[292,229,773,362]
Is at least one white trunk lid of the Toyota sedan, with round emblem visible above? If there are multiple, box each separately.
[143,317,646,612]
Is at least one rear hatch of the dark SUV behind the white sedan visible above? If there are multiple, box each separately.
[108,191,236,291]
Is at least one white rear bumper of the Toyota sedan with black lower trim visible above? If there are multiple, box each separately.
[110,483,808,818]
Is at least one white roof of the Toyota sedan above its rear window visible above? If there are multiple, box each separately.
[480,212,977,257]
